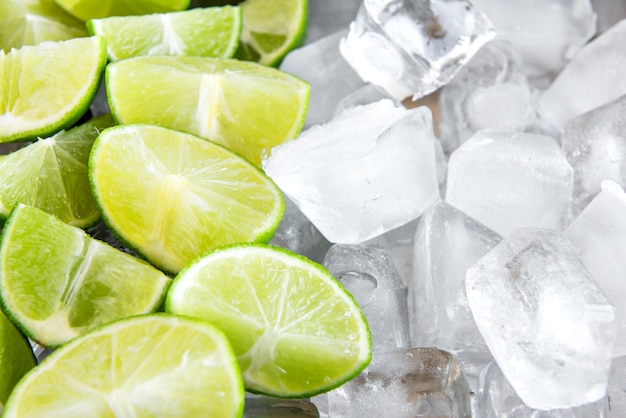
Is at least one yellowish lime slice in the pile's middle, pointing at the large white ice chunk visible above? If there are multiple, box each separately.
[89,124,284,272]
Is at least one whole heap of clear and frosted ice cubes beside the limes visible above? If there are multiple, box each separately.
[260,0,626,418]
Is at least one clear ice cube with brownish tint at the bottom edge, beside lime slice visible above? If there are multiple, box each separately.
[328,348,471,418]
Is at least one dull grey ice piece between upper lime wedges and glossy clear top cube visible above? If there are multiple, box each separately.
[280,30,365,128]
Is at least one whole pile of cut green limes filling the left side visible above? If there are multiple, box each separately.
[0,0,371,418]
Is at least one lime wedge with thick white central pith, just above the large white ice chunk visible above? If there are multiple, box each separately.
[106,56,309,166]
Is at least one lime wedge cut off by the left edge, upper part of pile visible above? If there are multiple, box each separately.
[0,36,107,142]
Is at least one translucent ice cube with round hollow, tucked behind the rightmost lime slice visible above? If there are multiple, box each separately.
[323,245,409,351]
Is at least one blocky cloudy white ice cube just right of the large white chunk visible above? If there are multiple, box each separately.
[445,130,573,236]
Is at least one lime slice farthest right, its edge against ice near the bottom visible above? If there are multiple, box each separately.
[166,244,371,397]
